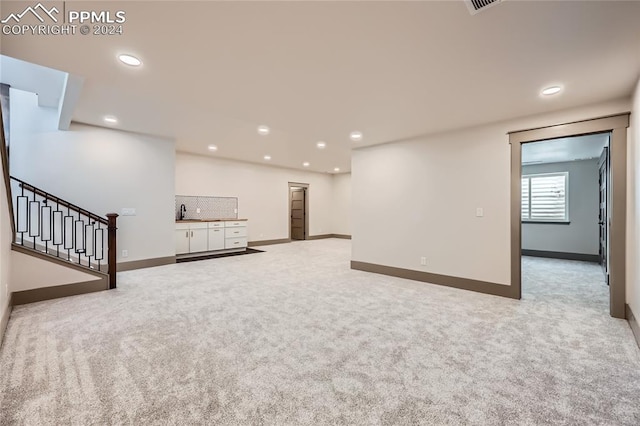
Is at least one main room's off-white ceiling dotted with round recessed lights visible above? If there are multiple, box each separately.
[0,0,640,172]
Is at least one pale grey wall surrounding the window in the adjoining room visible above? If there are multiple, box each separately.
[522,159,600,255]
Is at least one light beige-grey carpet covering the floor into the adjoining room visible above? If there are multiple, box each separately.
[0,239,640,425]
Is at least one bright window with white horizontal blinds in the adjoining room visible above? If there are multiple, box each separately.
[522,172,569,222]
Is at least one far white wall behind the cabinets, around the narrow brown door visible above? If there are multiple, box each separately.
[175,152,333,241]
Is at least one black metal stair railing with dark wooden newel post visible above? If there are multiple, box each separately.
[11,176,118,288]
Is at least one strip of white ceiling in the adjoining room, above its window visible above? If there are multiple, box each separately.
[522,133,609,165]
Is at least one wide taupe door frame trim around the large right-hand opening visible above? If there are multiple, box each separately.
[509,113,629,318]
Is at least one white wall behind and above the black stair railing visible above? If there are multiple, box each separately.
[10,90,175,262]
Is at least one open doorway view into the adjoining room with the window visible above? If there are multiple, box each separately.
[521,132,610,311]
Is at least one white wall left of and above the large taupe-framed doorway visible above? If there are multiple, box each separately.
[352,99,630,285]
